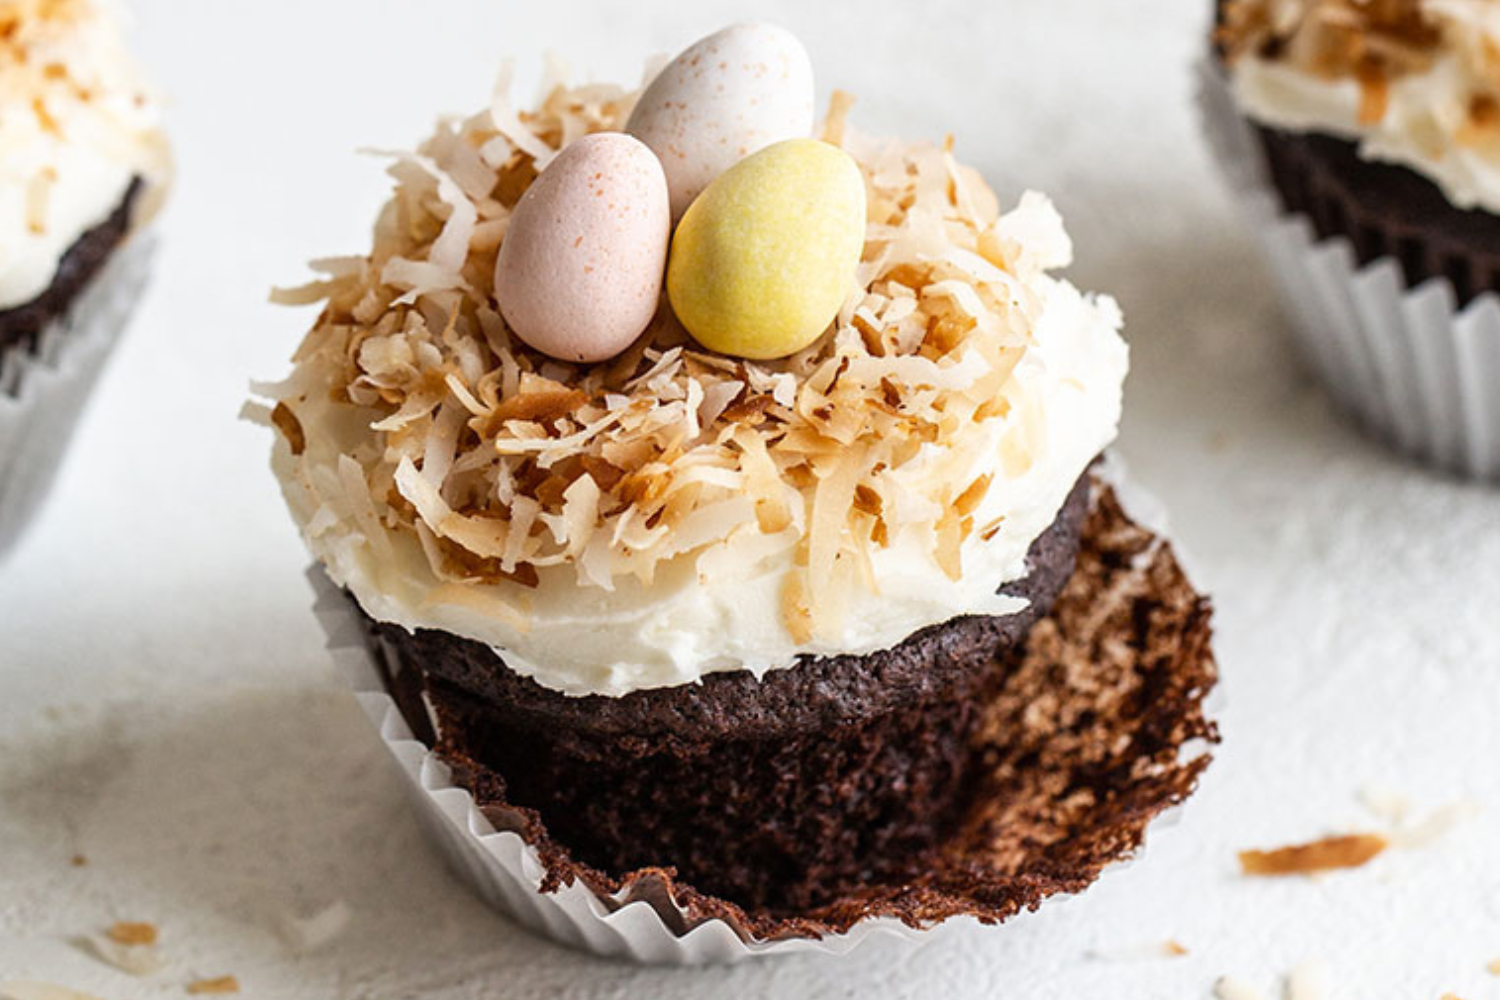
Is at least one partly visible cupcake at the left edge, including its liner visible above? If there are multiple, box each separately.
[0,0,170,552]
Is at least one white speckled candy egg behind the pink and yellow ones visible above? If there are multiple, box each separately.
[626,24,813,220]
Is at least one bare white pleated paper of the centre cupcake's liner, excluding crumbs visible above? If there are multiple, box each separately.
[308,470,1223,966]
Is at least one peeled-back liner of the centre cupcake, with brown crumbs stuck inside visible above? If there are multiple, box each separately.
[308,484,1217,966]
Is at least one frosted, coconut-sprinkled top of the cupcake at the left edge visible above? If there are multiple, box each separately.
[0,0,170,309]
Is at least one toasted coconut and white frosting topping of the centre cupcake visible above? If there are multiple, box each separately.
[260,27,1127,696]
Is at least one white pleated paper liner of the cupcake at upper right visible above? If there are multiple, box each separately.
[1197,58,1500,480]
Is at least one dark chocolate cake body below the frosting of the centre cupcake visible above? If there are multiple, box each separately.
[366,470,1089,913]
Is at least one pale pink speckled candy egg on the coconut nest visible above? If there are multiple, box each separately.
[495,132,672,361]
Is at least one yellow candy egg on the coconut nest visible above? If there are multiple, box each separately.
[666,139,864,360]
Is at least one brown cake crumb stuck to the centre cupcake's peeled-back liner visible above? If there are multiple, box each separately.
[366,484,1218,940]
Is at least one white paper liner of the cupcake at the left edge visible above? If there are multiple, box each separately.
[0,234,155,556]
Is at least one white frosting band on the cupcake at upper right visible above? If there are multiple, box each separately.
[1232,17,1500,213]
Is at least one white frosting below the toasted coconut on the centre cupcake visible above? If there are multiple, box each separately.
[275,276,1128,696]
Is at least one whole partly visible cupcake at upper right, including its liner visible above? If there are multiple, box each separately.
[1205,0,1500,478]
